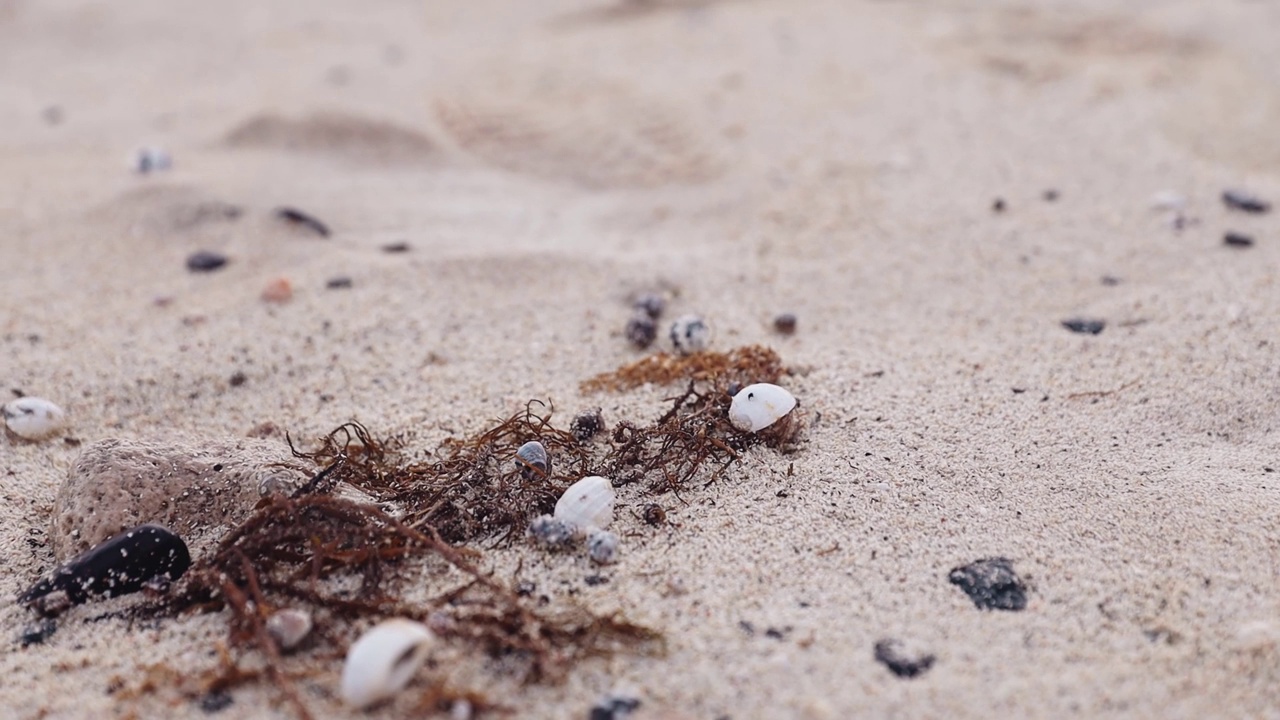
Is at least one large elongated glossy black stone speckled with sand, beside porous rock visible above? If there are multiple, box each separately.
[18,525,191,605]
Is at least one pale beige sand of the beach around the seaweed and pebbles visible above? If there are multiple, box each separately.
[0,0,1280,720]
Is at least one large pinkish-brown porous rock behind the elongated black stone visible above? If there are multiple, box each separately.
[50,430,306,562]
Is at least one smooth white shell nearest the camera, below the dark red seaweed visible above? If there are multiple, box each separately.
[342,618,435,708]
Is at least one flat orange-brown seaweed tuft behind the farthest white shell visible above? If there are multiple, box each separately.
[582,345,786,392]
